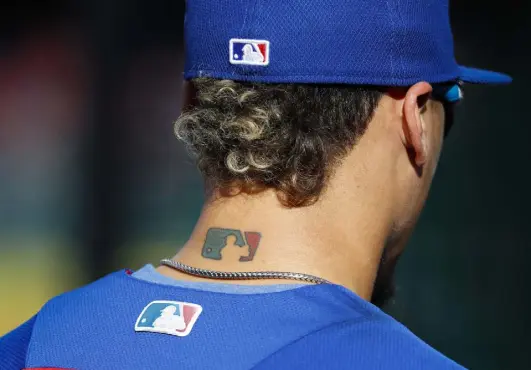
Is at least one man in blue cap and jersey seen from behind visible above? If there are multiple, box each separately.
[0,0,510,369]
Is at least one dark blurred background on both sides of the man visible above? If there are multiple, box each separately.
[0,0,531,369]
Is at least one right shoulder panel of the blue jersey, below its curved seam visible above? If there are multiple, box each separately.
[255,315,464,370]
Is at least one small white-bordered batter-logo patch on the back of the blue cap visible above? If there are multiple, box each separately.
[230,39,269,66]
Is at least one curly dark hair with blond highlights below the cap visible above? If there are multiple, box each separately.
[175,78,382,207]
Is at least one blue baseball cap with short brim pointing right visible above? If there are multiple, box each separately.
[184,0,511,86]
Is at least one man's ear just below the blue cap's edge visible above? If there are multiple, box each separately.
[402,82,433,168]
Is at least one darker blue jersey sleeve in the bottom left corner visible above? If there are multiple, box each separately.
[0,316,37,370]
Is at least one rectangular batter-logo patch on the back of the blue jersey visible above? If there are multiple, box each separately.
[135,301,203,337]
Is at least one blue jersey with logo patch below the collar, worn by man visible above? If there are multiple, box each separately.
[0,271,463,370]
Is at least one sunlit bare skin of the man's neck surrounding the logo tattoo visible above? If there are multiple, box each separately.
[159,117,398,300]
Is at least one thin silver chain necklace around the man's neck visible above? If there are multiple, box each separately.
[160,258,331,284]
